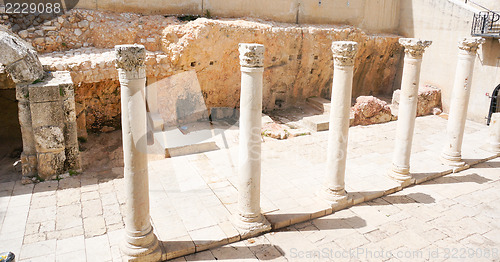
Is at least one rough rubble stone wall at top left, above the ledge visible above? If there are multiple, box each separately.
[3,9,178,53]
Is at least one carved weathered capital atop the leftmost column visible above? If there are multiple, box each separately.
[115,44,146,71]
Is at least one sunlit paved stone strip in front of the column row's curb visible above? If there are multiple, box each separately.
[178,158,500,261]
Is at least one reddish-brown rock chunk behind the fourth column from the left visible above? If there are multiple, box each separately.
[391,85,442,117]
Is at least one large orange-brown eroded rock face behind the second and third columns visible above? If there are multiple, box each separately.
[162,18,402,110]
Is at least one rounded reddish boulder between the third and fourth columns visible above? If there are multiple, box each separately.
[353,96,392,125]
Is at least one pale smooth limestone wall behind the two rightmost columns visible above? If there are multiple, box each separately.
[400,0,500,123]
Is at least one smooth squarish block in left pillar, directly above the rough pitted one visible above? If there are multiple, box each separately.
[31,101,64,128]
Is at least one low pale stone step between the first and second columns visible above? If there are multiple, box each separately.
[154,124,219,158]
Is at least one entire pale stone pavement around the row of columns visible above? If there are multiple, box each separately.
[0,116,500,261]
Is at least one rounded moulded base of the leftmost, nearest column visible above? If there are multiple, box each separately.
[120,227,162,262]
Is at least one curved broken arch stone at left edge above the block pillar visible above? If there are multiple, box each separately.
[0,26,43,83]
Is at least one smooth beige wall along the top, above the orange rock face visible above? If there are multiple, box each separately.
[73,0,400,32]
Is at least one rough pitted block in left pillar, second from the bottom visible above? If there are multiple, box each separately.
[33,126,65,153]
